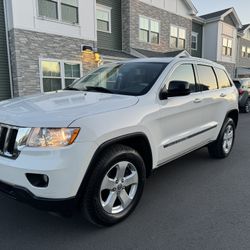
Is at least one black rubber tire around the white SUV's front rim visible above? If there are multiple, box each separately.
[80,145,146,226]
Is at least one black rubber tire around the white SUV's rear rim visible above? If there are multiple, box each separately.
[208,118,235,159]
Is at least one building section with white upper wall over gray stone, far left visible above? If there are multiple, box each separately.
[1,0,97,96]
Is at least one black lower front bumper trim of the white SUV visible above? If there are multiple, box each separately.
[0,181,77,215]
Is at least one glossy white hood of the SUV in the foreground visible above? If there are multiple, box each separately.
[0,91,138,127]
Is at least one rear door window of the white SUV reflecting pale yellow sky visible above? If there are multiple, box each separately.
[197,65,218,91]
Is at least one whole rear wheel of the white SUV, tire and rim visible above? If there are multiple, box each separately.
[208,118,235,159]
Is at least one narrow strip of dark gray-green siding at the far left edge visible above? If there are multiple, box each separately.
[0,0,10,101]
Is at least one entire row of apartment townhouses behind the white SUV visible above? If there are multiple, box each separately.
[0,0,250,99]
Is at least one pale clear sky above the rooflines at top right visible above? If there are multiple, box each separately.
[192,0,250,24]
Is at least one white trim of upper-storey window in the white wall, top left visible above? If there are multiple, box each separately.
[36,0,80,26]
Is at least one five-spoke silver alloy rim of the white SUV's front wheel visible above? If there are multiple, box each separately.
[100,161,138,214]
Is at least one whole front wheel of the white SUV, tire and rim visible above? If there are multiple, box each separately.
[81,145,146,226]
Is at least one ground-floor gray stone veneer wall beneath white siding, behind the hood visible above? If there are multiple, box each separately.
[9,29,96,96]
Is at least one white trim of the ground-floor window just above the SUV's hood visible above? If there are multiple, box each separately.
[39,58,83,93]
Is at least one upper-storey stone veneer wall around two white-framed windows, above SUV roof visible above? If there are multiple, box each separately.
[126,0,192,53]
